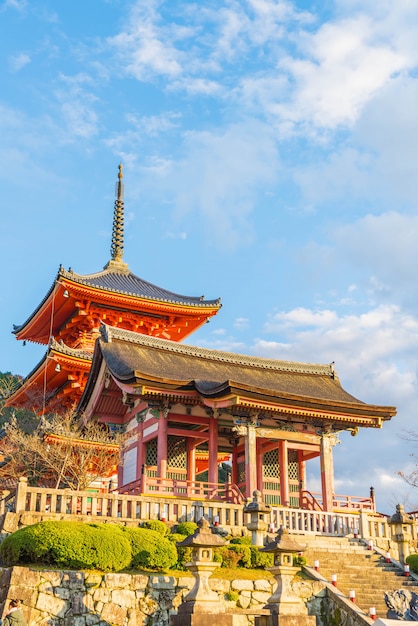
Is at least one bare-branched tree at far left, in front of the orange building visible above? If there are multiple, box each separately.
[0,411,123,490]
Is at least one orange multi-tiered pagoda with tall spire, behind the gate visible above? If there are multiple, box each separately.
[7,165,221,413]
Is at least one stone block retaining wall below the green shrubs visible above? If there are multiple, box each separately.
[0,567,323,626]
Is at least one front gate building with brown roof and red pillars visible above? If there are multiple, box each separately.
[78,325,396,511]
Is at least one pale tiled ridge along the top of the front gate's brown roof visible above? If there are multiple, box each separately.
[100,324,336,378]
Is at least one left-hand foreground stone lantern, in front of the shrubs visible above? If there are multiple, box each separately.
[170,517,233,626]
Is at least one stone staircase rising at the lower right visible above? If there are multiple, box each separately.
[304,538,418,618]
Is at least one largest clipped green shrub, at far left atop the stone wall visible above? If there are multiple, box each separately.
[0,521,132,572]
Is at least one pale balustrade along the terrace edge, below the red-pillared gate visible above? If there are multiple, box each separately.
[0,478,398,539]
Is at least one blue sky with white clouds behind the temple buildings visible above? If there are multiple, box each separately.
[0,0,418,512]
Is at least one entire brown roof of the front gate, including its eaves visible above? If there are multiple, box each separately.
[78,325,396,426]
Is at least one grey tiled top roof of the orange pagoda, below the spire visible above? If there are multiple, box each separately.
[60,268,220,307]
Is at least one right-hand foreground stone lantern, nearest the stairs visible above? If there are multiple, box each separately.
[255,528,315,626]
